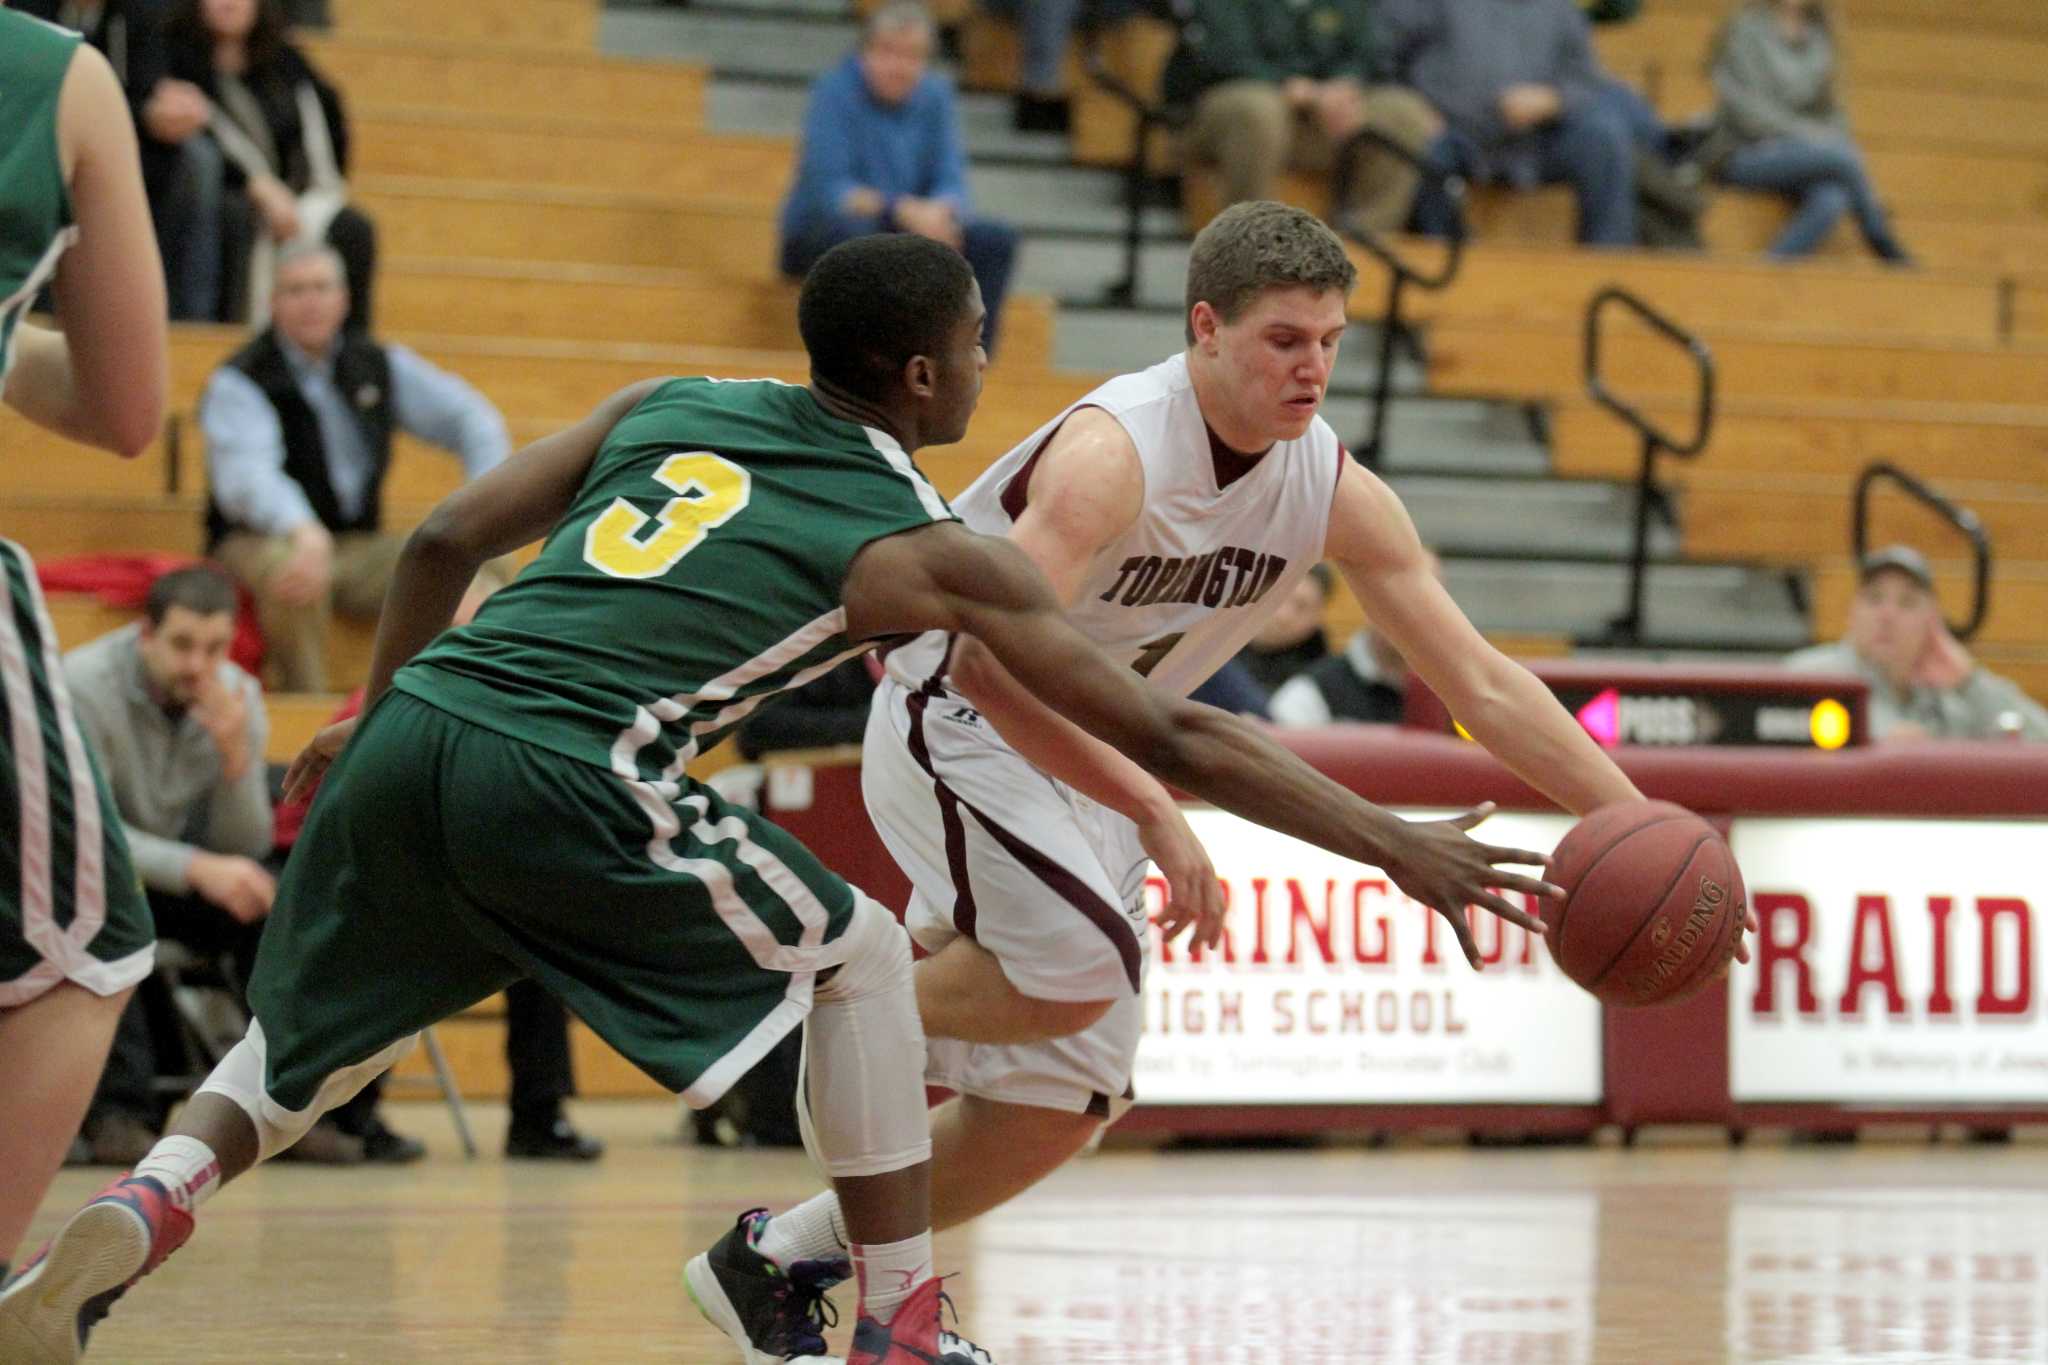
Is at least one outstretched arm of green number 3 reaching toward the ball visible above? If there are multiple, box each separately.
[844,522,1556,966]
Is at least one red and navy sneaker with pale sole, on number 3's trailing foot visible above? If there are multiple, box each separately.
[0,1175,193,1365]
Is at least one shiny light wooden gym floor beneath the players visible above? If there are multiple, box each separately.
[19,1103,2048,1365]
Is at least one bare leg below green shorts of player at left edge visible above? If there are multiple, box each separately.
[0,982,131,1281]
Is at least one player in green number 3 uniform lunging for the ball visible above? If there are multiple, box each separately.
[0,233,1544,1365]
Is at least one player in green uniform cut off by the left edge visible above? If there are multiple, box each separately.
[0,0,166,1281]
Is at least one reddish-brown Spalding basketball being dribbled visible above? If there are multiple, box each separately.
[1542,800,1747,1005]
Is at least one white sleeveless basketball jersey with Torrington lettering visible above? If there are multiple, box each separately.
[889,354,1348,696]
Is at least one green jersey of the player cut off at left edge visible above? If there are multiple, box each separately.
[0,8,78,379]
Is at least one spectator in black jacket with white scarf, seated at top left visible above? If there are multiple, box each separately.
[153,0,377,329]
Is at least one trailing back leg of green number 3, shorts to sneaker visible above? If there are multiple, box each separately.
[0,696,520,1361]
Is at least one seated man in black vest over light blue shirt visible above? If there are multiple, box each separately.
[199,246,508,692]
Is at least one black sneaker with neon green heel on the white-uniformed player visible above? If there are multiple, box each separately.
[682,1209,854,1365]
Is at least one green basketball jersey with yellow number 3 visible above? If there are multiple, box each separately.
[393,379,952,780]
